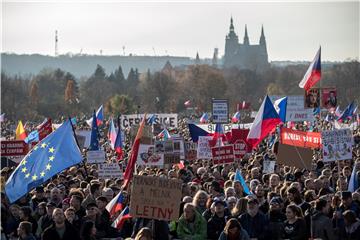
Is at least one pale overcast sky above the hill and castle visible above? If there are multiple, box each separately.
[1,1,359,61]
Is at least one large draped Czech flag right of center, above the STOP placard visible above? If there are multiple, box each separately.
[247,95,281,148]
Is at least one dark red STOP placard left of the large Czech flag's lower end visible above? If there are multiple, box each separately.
[231,129,251,159]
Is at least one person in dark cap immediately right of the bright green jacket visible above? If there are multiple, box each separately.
[207,199,228,240]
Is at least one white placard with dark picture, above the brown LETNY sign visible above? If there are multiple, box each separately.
[136,144,164,166]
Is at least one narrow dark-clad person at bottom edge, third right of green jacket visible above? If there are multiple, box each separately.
[267,196,286,240]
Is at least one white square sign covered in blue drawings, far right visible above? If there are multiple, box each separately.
[321,129,353,162]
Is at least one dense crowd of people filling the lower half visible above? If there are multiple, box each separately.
[1,114,360,240]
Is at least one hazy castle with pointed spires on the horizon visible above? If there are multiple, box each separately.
[223,18,270,71]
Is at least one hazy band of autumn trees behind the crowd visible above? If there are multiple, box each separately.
[1,61,360,120]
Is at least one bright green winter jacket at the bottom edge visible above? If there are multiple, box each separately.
[176,211,207,240]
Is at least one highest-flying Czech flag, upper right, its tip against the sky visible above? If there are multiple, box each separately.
[299,47,321,91]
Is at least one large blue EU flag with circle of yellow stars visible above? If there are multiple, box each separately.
[5,120,82,203]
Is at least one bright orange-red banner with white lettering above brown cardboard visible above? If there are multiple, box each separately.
[280,128,321,148]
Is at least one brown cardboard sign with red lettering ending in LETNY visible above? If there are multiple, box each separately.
[130,175,182,221]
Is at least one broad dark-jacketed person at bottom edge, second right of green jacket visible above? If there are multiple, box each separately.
[239,196,268,240]
